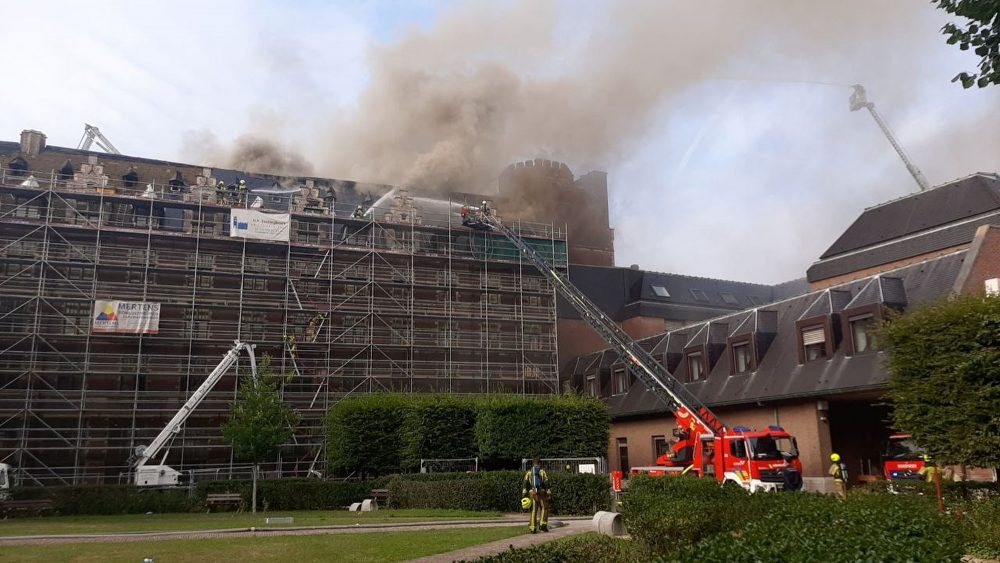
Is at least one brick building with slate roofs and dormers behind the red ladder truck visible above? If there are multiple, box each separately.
[560,174,1000,489]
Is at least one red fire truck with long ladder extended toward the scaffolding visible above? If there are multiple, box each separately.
[462,201,802,492]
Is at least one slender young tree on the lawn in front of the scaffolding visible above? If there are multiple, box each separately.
[222,355,301,512]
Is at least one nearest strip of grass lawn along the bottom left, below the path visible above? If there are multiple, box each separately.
[0,526,525,563]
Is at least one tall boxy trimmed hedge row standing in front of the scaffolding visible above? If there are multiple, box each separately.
[326,394,611,476]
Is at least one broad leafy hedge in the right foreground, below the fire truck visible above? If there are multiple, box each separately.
[623,477,964,562]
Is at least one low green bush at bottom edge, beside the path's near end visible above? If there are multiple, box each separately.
[460,534,650,563]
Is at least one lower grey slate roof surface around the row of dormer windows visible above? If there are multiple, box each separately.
[563,250,966,418]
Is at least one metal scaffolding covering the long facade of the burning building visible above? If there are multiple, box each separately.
[0,163,567,485]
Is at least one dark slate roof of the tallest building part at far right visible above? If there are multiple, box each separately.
[806,173,1000,281]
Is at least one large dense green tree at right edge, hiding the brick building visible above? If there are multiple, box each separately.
[882,295,1000,467]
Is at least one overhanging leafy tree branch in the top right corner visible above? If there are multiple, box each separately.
[931,0,1000,88]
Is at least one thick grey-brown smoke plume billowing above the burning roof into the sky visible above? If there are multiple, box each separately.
[321,0,972,190]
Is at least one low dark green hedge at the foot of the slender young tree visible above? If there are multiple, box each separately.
[197,479,378,510]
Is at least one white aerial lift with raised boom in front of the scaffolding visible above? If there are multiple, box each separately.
[132,340,257,487]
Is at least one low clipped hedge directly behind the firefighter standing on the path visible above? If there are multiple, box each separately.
[389,471,611,515]
